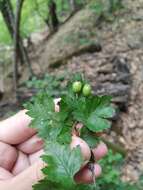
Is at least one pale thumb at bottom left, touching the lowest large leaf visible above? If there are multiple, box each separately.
[12,160,45,190]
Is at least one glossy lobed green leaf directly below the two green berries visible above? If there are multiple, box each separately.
[73,96,115,132]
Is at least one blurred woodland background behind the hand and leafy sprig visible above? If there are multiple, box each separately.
[0,0,143,190]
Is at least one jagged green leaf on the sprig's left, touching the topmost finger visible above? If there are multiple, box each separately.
[26,93,67,140]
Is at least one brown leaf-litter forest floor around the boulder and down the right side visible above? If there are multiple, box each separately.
[0,0,143,181]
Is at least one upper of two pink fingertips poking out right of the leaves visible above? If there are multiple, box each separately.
[92,142,108,160]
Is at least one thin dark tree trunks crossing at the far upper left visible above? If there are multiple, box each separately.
[0,0,33,94]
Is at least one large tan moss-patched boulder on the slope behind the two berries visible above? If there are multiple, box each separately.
[42,8,101,67]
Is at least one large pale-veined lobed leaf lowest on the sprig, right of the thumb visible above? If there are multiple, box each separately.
[43,142,83,188]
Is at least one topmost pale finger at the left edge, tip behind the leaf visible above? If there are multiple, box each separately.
[0,110,36,144]
